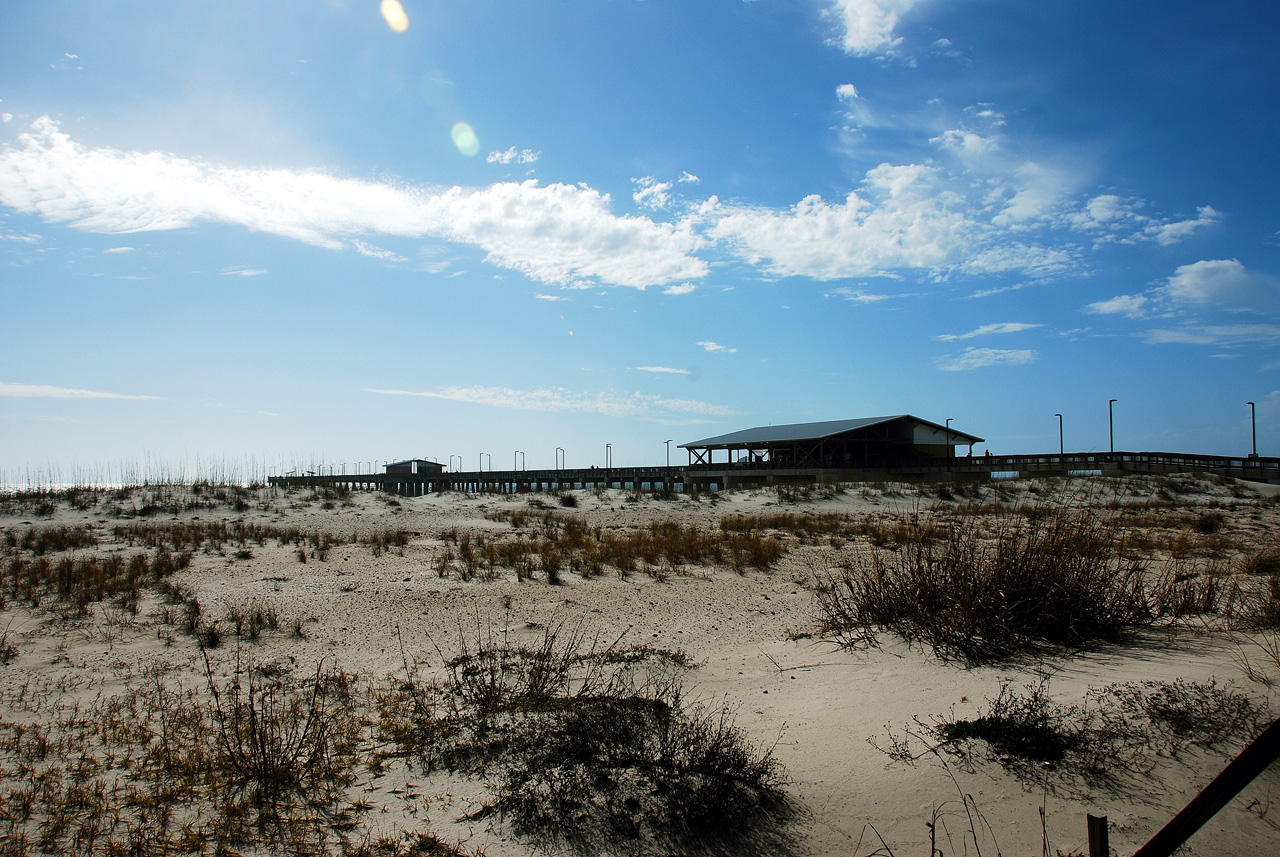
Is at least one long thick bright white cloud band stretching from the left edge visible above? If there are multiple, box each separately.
[0,118,708,288]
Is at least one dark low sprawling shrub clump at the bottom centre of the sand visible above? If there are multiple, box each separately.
[383,625,791,853]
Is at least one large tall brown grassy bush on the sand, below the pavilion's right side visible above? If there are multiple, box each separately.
[815,509,1156,663]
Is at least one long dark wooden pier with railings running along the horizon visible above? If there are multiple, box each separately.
[268,453,1280,496]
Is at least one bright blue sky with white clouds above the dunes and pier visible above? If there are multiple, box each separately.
[0,0,1280,484]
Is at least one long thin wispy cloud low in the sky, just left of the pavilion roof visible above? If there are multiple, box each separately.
[366,386,737,422]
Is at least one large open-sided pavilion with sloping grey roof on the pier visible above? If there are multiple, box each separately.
[680,413,983,469]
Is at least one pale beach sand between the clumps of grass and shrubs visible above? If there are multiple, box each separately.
[0,478,1280,857]
